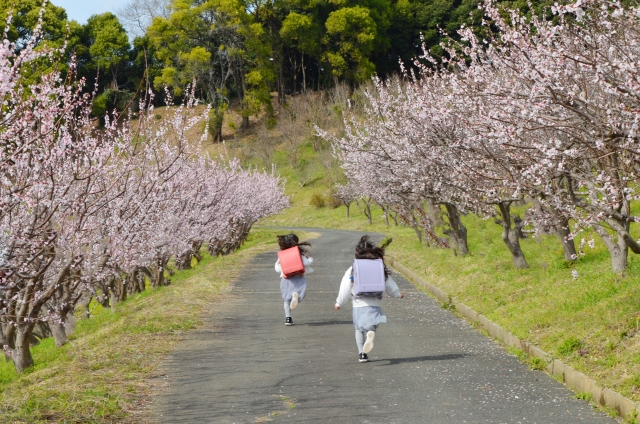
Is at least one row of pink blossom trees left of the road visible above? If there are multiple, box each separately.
[0,19,288,371]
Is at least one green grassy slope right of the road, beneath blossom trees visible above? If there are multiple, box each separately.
[255,139,640,401]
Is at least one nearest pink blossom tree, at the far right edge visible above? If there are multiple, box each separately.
[450,0,640,272]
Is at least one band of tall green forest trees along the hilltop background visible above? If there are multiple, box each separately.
[5,0,568,141]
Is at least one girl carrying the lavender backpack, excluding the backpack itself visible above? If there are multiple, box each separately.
[335,236,404,362]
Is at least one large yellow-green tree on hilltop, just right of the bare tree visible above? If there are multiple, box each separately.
[148,0,273,137]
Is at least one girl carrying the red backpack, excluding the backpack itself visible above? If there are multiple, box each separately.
[275,234,313,325]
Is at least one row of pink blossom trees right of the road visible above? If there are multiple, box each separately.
[320,0,640,272]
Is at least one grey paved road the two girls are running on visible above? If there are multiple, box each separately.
[153,230,615,424]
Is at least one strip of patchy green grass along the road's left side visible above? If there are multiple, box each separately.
[0,229,313,422]
